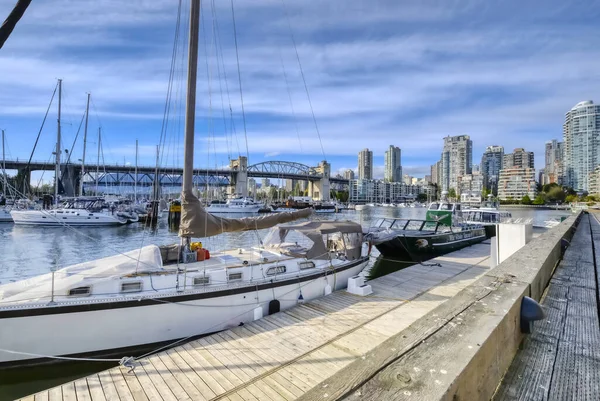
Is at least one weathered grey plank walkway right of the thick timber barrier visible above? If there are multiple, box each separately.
[494,214,600,401]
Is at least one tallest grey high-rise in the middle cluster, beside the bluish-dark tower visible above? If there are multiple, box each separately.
[441,135,473,191]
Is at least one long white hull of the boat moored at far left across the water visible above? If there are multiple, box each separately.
[10,210,127,227]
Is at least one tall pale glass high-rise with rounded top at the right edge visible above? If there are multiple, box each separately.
[563,100,600,191]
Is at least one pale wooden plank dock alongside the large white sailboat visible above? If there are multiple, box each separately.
[23,241,490,401]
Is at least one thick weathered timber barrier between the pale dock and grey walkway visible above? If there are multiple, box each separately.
[301,214,581,401]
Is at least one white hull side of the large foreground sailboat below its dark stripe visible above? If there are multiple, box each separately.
[0,259,368,367]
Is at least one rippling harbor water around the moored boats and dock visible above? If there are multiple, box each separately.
[0,207,568,401]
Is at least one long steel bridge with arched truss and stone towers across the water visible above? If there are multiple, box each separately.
[5,156,349,200]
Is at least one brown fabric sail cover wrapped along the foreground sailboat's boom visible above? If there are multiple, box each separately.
[179,191,313,238]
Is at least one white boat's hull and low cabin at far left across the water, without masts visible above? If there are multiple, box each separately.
[10,197,138,226]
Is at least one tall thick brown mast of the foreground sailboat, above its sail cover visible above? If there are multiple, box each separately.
[182,0,200,200]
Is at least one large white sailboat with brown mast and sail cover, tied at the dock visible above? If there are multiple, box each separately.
[0,0,369,368]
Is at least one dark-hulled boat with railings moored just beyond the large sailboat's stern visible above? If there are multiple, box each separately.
[369,219,486,262]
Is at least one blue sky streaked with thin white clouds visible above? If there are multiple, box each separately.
[0,0,600,177]
